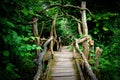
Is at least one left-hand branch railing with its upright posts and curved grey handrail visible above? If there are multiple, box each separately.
[31,13,59,80]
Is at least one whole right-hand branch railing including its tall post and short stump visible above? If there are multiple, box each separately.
[72,1,102,80]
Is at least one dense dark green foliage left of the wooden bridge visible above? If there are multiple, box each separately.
[0,0,43,80]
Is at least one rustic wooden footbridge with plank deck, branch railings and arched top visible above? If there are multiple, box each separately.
[32,1,102,80]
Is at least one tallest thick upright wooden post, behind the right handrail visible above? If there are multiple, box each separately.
[81,1,89,59]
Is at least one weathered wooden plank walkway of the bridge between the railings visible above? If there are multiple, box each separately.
[50,46,78,80]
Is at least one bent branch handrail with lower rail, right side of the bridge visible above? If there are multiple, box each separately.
[73,37,97,80]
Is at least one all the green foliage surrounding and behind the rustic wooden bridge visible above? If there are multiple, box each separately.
[0,0,120,80]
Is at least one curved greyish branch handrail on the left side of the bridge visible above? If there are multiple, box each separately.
[34,36,54,80]
